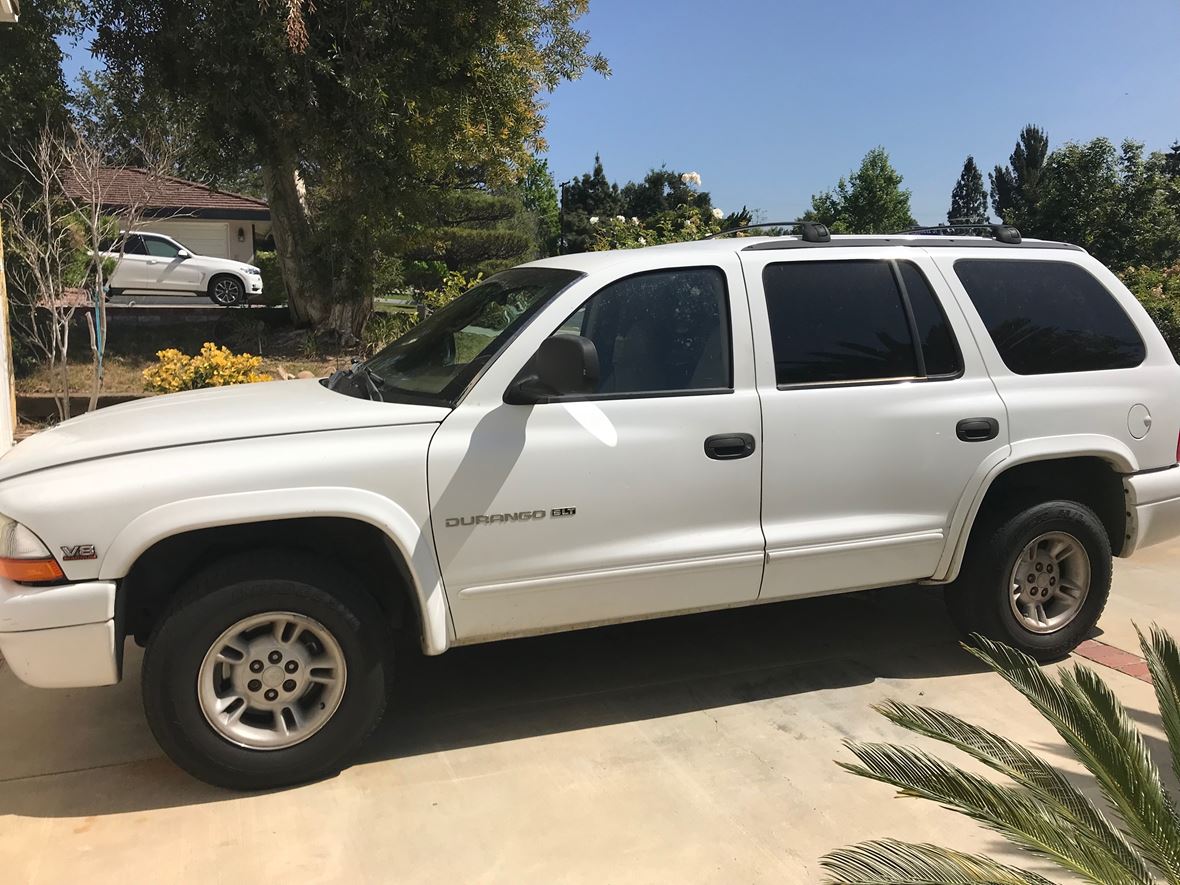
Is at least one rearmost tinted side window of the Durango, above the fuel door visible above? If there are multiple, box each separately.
[955,258,1145,375]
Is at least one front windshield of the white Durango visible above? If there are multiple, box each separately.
[365,268,582,402]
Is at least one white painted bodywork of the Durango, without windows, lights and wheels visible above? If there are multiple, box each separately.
[0,237,1180,686]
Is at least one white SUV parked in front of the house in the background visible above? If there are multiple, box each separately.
[101,230,262,307]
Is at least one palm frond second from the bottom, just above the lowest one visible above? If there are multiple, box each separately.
[840,741,1151,885]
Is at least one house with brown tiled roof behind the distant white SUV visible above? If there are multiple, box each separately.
[64,166,273,263]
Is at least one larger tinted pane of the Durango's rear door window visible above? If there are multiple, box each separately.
[762,261,918,385]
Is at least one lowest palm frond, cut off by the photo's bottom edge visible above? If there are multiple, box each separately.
[820,839,1053,885]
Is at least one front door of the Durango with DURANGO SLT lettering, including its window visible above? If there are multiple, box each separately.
[428,255,763,641]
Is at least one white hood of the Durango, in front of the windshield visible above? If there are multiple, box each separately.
[0,379,450,480]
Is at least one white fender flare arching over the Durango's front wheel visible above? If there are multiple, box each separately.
[98,486,451,655]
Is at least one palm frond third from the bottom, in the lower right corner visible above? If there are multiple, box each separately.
[876,701,1152,883]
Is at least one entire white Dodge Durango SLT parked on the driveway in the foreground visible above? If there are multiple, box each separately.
[0,225,1180,788]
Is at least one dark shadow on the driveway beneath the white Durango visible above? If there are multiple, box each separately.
[0,586,983,818]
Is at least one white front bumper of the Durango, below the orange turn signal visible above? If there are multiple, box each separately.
[0,578,120,688]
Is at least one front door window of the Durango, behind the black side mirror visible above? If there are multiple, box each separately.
[558,268,733,395]
